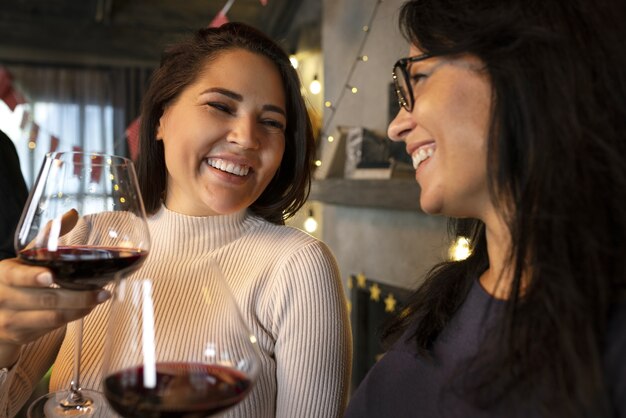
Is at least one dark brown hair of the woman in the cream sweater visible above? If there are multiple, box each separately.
[137,23,315,224]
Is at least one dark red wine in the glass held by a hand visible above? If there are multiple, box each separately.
[18,245,148,290]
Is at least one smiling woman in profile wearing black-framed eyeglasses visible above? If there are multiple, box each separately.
[346,0,626,418]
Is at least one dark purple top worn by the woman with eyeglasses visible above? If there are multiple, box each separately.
[345,280,626,418]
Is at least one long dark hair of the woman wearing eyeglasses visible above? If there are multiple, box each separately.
[385,0,626,417]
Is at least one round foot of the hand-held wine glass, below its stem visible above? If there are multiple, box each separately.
[27,389,111,418]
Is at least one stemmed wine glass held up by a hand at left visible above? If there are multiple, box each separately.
[15,152,150,418]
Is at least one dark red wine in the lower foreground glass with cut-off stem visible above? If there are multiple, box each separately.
[104,362,252,418]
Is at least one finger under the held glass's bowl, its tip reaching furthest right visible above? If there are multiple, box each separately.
[0,286,111,311]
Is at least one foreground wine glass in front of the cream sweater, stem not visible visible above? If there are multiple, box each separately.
[102,258,260,418]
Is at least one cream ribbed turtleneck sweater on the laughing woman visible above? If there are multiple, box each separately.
[0,208,351,418]
